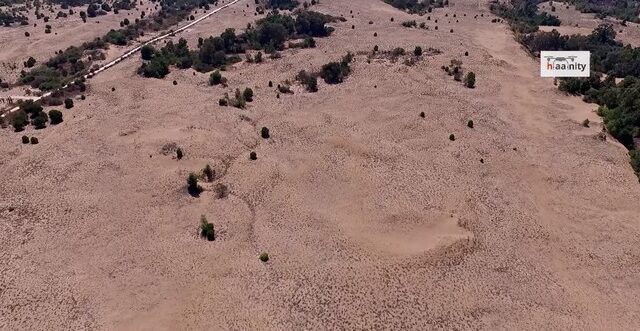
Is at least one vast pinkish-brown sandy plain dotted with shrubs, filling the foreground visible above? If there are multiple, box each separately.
[0,0,640,330]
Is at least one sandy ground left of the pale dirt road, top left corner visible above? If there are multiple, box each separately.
[0,0,156,81]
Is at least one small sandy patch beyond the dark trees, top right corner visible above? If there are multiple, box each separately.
[538,2,640,47]
